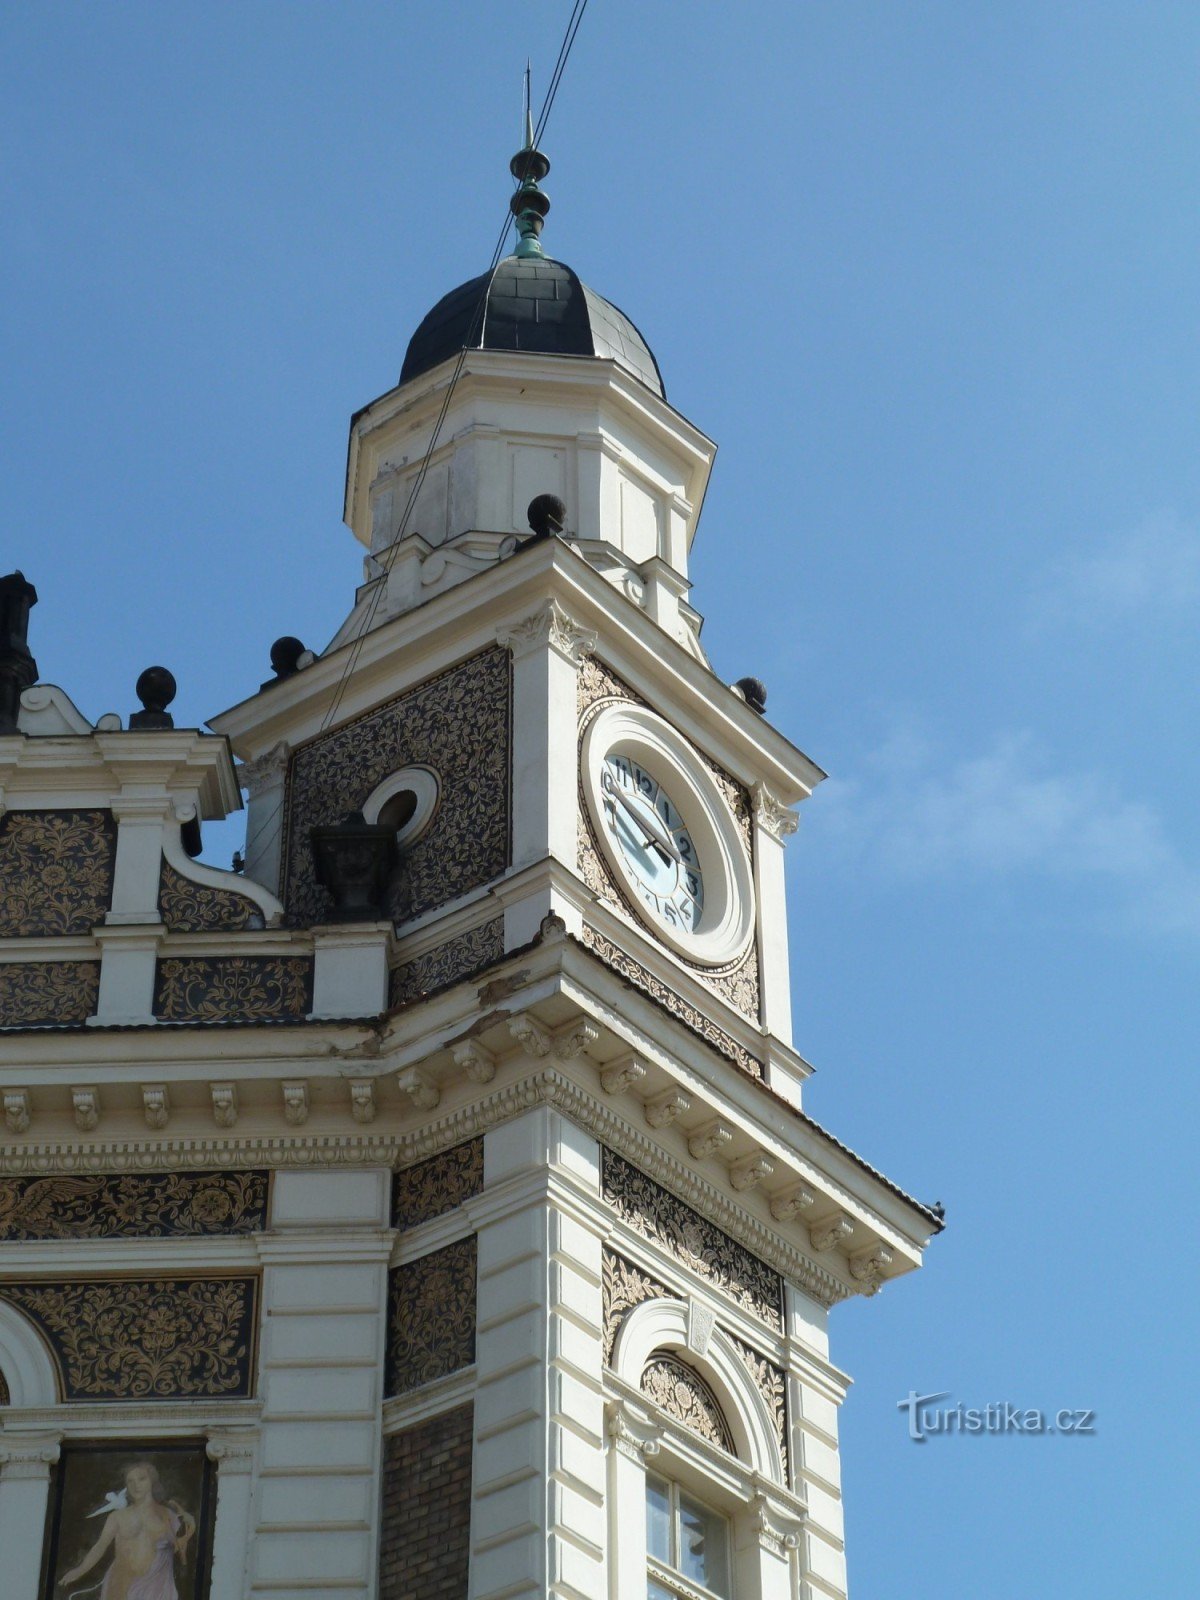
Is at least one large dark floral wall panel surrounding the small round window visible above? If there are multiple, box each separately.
[283,648,512,926]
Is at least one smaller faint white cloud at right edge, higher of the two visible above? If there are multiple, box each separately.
[1029,514,1200,627]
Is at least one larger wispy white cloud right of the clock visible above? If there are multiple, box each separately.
[814,728,1200,934]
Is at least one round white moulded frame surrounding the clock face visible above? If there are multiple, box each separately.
[579,704,754,966]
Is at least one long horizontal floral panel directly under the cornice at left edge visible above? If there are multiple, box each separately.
[0,1173,267,1242]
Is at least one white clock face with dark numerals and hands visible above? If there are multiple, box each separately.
[600,752,704,933]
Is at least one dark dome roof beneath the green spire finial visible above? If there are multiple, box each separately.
[400,256,666,398]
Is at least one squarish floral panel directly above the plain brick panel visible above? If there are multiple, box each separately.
[384,1234,475,1395]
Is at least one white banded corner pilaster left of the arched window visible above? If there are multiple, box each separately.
[469,1107,604,1600]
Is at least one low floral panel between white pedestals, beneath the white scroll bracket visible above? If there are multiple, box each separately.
[154,955,312,1022]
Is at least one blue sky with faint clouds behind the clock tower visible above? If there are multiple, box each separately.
[0,0,1200,1600]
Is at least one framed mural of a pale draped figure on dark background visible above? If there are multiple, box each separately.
[42,1438,216,1600]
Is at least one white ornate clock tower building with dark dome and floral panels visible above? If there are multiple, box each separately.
[0,139,941,1600]
